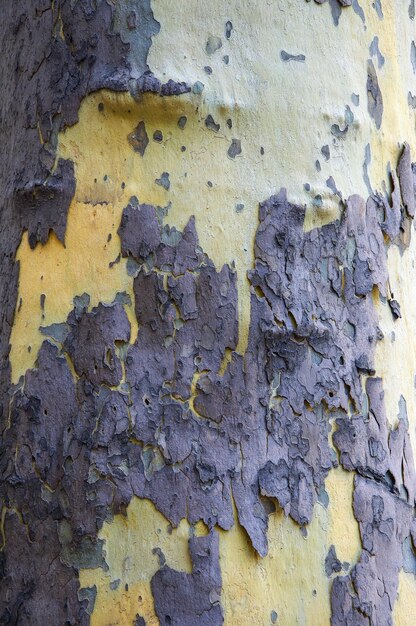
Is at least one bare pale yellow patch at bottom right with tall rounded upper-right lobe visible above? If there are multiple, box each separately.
[219,468,361,626]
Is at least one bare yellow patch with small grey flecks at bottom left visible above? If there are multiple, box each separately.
[80,497,192,626]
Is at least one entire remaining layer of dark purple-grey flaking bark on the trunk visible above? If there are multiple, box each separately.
[0,0,416,626]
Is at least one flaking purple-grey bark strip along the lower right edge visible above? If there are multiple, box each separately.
[331,378,416,626]
